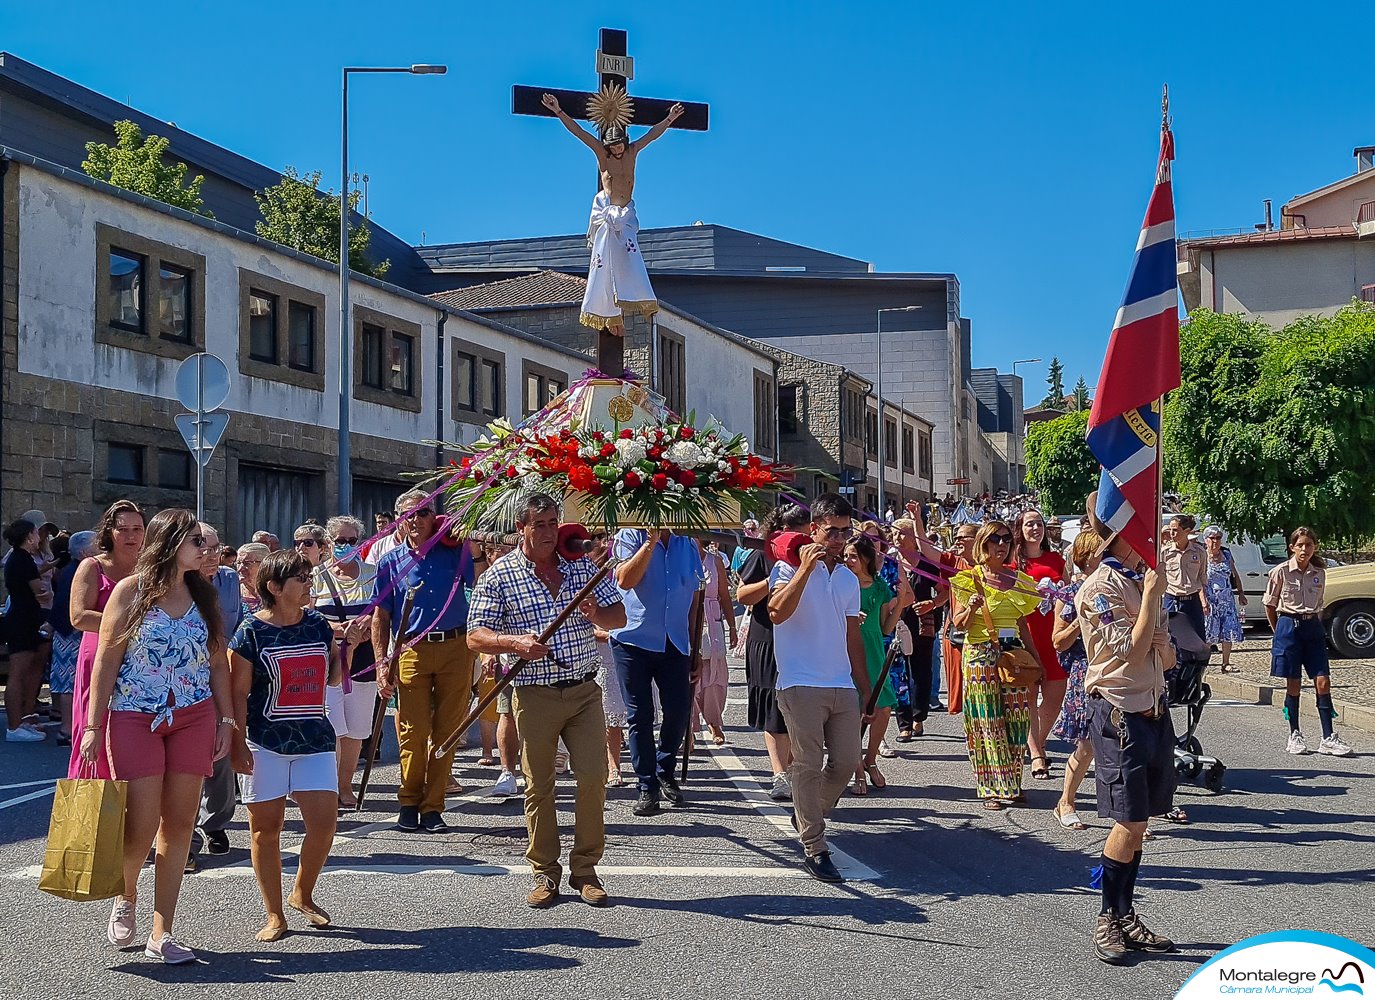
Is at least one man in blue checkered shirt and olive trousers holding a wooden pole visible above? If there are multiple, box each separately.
[468,492,626,908]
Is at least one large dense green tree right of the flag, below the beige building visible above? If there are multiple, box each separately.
[1165,303,1375,545]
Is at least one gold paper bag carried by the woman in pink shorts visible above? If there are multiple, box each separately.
[39,765,129,902]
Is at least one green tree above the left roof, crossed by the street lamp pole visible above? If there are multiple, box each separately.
[254,166,392,278]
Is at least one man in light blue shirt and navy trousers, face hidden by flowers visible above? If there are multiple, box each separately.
[611,528,703,816]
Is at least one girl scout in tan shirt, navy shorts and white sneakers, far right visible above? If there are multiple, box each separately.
[1265,528,1352,757]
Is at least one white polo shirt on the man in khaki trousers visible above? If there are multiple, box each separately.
[769,563,859,691]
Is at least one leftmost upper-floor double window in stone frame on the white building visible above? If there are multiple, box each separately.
[94,223,205,360]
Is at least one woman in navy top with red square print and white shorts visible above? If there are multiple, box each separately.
[230,550,341,941]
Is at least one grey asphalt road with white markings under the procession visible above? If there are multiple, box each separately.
[0,670,1375,1000]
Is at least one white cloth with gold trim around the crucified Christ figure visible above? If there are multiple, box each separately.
[579,191,659,330]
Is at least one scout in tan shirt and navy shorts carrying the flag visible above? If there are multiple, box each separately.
[1074,494,1176,964]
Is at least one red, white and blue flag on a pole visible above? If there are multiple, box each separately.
[1088,128,1180,569]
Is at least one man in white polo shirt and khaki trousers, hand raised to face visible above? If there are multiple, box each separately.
[769,492,870,882]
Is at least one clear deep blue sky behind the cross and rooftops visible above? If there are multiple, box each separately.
[0,0,1375,396]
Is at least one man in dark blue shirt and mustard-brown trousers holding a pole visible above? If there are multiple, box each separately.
[373,490,474,834]
